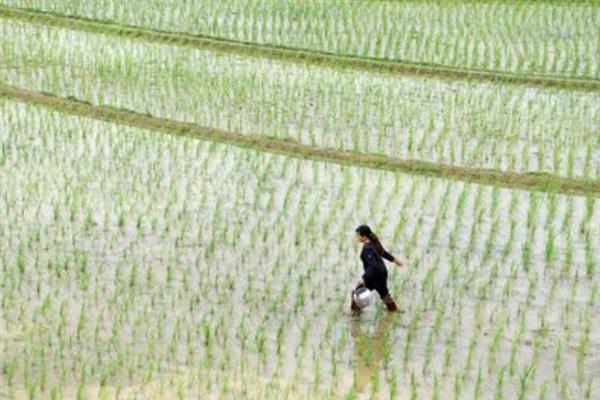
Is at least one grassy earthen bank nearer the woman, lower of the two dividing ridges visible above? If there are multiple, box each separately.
[0,83,600,197]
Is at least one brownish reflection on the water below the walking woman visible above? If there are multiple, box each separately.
[350,313,395,393]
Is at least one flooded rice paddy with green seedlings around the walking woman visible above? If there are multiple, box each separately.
[0,99,600,399]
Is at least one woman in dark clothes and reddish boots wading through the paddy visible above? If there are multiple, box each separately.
[351,225,404,311]
